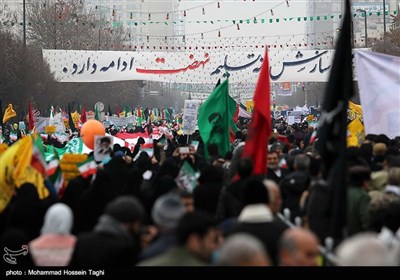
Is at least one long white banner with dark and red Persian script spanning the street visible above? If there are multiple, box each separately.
[43,49,346,84]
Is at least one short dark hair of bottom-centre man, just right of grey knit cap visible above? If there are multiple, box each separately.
[176,210,216,245]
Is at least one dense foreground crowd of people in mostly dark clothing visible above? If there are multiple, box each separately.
[0,110,400,267]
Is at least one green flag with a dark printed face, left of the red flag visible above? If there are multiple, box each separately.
[197,80,236,159]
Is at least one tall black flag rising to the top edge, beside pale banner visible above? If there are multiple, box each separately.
[317,0,354,241]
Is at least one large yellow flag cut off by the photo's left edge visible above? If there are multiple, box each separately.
[0,137,32,213]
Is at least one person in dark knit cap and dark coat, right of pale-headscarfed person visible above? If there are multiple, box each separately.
[70,196,144,267]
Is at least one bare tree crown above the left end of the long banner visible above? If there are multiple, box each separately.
[27,0,127,50]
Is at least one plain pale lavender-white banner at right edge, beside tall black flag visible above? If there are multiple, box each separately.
[355,51,400,138]
